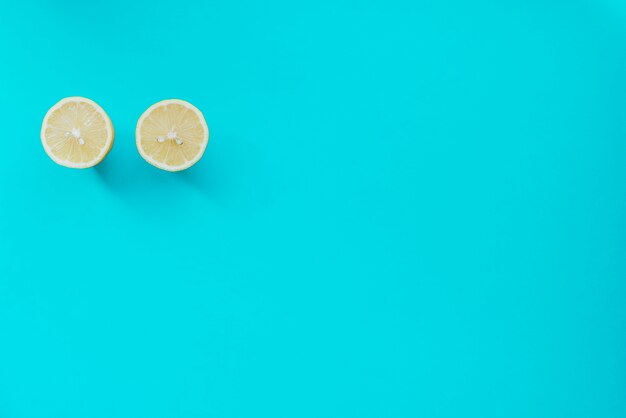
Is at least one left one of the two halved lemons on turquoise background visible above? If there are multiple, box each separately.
[41,97,114,168]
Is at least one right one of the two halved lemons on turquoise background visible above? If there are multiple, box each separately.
[135,99,209,171]
